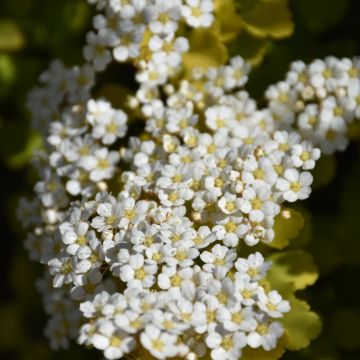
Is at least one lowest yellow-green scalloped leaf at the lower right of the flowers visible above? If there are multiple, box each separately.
[280,296,322,350]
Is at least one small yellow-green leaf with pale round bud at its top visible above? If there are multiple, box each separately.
[268,209,304,249]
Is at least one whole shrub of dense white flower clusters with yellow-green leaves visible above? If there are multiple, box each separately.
[19,0,360,360]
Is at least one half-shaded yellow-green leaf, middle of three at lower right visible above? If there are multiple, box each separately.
[267,250,318,296]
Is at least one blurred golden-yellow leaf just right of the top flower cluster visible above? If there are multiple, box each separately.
[183,29,227,70]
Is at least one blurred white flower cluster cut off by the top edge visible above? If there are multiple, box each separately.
[84,0,214,80]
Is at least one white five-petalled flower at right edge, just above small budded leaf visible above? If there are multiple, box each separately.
[276,169,313,202]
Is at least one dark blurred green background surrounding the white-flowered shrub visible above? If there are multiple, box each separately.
[0,0,360,360]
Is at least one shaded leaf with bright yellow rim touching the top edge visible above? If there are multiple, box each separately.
[241,0,294,39]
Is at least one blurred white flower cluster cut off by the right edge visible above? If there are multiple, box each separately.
[266,57,360,154]
